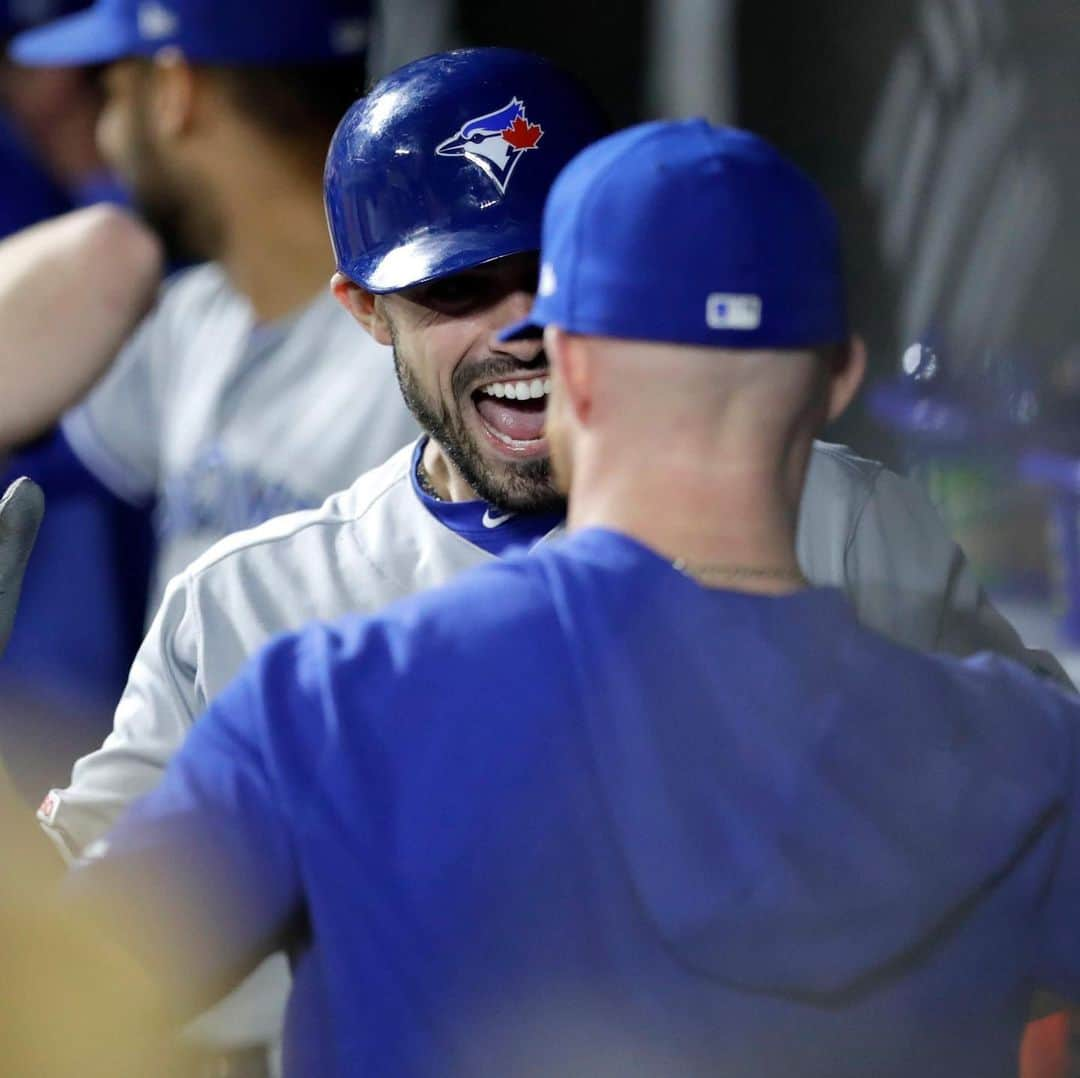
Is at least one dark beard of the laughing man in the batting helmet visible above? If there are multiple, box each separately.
[393,335,566,513]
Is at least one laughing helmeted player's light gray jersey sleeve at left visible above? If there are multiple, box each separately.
[38,575,203,858]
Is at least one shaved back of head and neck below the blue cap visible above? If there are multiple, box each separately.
[545,326,865,572]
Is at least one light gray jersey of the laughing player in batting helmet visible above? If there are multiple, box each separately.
[39,434,1064,1043]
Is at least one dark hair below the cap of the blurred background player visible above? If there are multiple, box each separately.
[213,59,367,151]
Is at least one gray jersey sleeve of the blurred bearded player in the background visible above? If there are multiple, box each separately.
[60,307,164,506]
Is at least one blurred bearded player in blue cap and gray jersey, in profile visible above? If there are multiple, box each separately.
[0,0,415,807]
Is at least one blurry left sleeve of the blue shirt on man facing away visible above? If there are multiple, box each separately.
[67,663,301,1012]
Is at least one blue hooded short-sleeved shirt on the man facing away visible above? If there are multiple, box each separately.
[72,530,1080,1078]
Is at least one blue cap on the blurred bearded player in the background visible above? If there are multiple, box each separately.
[10,0,370,67]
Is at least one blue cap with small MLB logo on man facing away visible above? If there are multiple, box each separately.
[500,120,848,349]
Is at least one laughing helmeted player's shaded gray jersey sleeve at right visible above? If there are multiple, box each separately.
[843,469,1071,688]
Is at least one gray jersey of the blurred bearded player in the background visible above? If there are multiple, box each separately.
[62,264,416,610]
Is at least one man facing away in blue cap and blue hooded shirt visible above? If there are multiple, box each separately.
[69,118,1080,1078]
